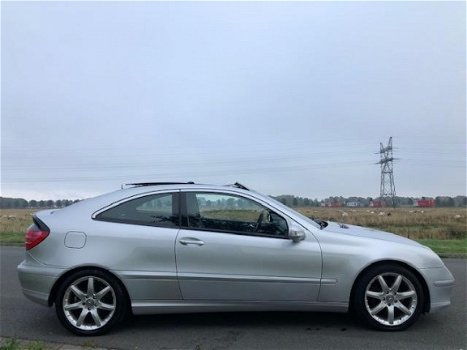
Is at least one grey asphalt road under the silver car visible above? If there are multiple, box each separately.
[0,247,467,350]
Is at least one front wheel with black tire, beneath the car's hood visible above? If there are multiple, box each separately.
[352,263,424,331]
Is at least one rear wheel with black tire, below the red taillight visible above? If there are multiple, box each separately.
[55,269,128,336]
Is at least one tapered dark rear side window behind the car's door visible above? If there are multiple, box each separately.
[96,193,179,227]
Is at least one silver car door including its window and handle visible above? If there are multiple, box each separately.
[175,191,321,301]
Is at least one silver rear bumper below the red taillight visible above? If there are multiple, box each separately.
[17,260,63,305]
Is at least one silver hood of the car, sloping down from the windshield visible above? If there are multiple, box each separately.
[323,221,423,247]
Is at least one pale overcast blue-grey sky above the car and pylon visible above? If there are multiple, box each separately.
[1,1,466,199]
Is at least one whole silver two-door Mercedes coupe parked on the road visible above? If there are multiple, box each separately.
[18,183,454,335]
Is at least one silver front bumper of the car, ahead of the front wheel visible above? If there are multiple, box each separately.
[420,266,455,312]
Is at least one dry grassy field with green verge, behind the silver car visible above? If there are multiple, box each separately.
[0,207,467,257]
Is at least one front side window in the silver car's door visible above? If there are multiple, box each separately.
[186,192,288,238]
